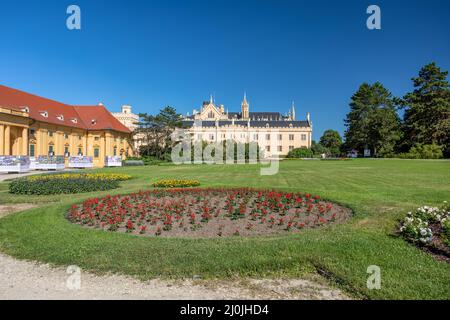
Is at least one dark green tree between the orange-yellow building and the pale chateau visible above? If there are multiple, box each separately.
[136,106,182,160]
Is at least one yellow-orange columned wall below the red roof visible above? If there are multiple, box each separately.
[0,108,133,167]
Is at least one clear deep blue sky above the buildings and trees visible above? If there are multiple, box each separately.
[0,0,450,139]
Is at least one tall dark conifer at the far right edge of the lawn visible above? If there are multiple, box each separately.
[402,62,450,157]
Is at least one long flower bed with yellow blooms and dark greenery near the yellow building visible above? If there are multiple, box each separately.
[9,173,131,195]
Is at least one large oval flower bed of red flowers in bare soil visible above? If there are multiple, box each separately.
[68,188,351,237]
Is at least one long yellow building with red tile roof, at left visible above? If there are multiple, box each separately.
[0,85,133,167]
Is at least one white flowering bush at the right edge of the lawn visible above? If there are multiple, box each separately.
[400,202,450,246]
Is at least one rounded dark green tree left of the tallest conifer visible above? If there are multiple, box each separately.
[344,82,401,156]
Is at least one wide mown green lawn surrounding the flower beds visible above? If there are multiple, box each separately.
[0,159,450,299]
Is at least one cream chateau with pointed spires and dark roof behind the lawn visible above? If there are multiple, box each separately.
[183,95,312,157]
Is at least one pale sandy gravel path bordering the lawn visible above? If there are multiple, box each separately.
[0,204,347,300]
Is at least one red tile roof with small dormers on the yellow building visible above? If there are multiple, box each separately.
[0,85,131,133]
